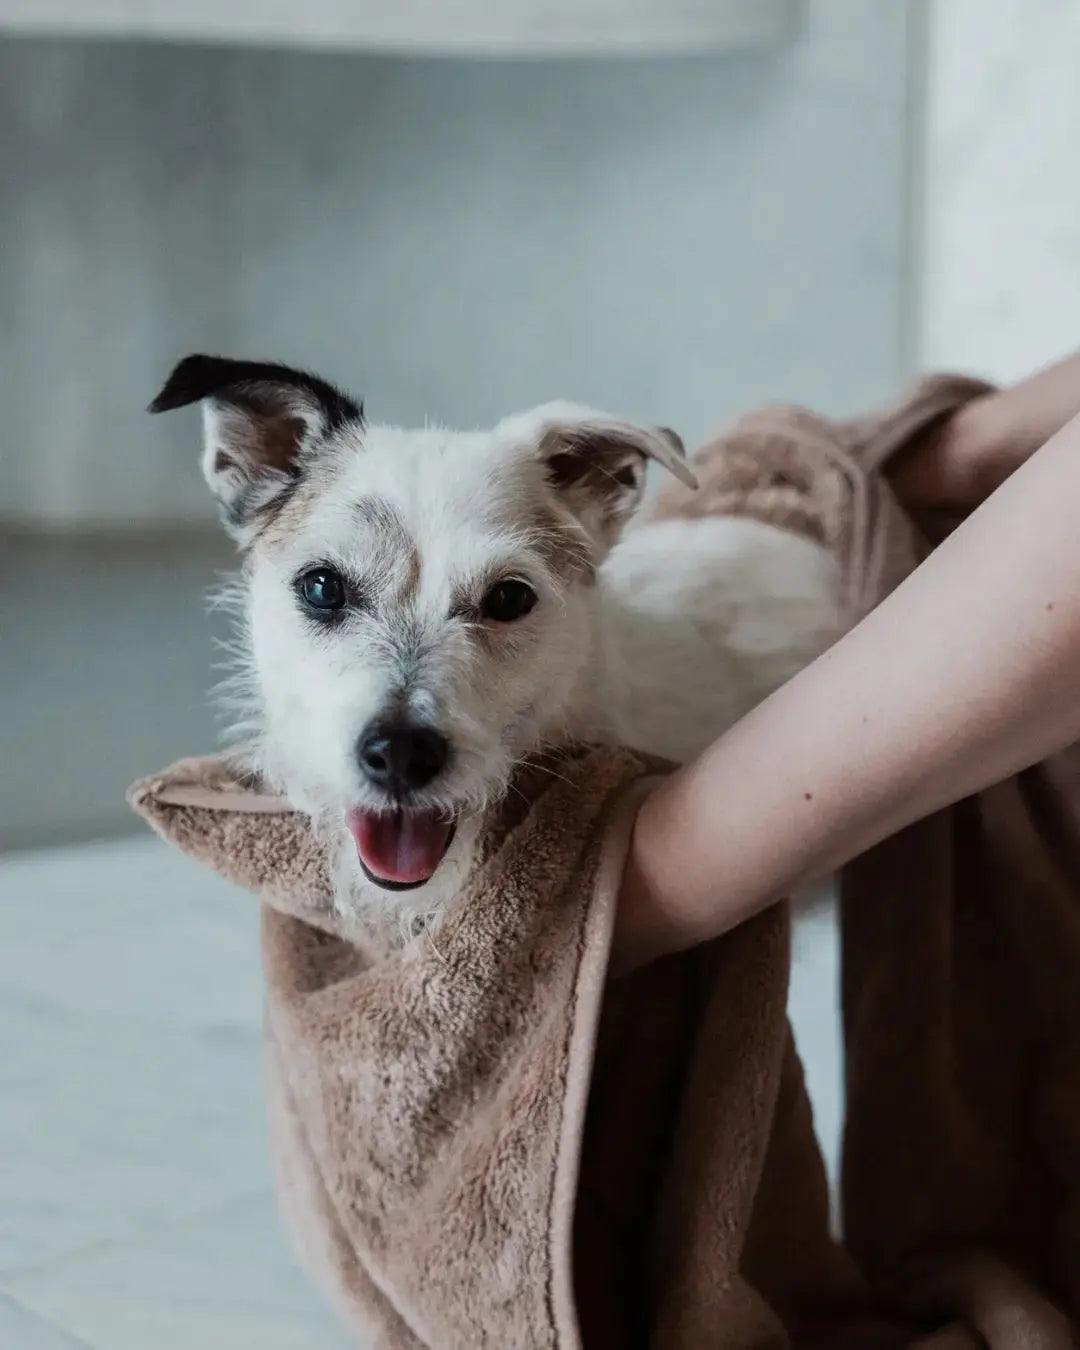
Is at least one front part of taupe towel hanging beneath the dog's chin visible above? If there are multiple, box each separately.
[132,749,876,1350]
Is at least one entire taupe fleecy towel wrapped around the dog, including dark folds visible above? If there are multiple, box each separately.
[131,377,1080,1350]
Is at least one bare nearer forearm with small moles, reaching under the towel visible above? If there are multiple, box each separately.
[616,405,1080,967]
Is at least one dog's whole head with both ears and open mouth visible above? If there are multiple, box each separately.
[153,356,687,907]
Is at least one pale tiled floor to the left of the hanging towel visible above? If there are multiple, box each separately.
[0,838,352,1350]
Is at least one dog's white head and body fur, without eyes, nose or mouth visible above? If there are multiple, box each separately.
[213,408,838,914]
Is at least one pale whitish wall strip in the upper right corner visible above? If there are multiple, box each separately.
[919,0,1080,381]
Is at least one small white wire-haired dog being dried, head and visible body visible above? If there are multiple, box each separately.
[150,355,837,922]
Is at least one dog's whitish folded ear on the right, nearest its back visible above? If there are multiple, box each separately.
[504,404,698,541]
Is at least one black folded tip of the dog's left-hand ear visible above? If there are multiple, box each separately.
[147,355,363,431]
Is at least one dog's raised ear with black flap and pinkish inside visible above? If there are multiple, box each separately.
[150,356,363,543]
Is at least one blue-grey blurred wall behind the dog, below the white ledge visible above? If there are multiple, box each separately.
[0,0,910,527]
